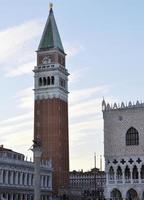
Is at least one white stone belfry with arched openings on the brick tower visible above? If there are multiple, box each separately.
[33,50,69,102]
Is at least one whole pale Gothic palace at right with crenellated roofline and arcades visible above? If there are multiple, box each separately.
[102,101,144,200]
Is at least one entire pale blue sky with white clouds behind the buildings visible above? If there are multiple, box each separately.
[0,0,144,170]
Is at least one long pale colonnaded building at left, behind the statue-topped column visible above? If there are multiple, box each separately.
[0,147,52,200]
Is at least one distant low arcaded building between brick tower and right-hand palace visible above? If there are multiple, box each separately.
[70,168,106,200]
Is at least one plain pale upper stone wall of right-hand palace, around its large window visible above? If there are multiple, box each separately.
[103,107,144,157]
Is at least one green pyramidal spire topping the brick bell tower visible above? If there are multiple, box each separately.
[38,4,64,53]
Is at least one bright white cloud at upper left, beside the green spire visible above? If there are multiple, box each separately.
[0,20,42,62]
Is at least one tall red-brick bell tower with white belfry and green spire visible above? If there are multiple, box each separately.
[34,5,69,194]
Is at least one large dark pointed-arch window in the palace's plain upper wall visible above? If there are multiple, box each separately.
[126,127,139,146]
